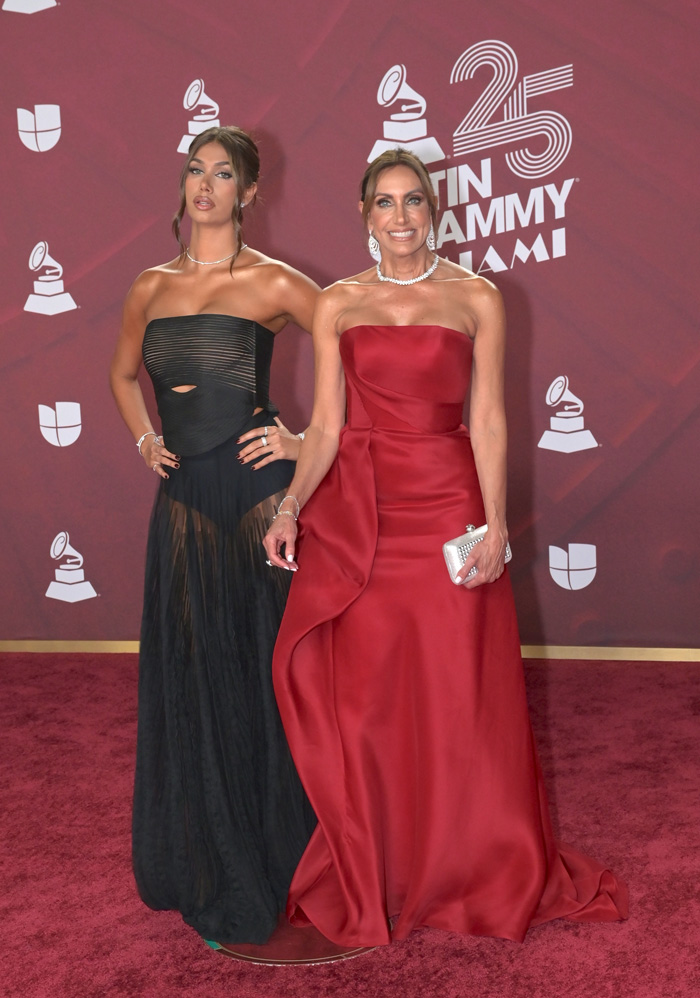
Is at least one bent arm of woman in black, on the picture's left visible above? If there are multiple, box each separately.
[109,271,177,478]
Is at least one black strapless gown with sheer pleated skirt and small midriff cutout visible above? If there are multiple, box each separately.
[133,315,315,943]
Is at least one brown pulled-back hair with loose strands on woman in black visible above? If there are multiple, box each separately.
[173,125,260,269]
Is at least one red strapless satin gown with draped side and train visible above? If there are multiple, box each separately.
[273,325,627,946]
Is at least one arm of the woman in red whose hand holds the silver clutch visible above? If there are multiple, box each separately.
[459,278,508,589]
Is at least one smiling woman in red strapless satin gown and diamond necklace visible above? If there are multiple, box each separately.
[265,150,627,946]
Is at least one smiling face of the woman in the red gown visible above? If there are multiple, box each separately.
[360,165,431,257]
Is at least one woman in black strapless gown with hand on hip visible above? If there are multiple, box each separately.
[111,127,318,943]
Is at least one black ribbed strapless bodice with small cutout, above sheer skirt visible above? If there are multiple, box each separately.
[143,314,276,456]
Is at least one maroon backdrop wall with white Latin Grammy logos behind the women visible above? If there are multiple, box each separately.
[0,0,700,648]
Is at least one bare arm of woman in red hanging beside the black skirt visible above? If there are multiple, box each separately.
[263,287,345,572]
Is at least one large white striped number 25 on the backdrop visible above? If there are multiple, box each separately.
[450,41,574,178]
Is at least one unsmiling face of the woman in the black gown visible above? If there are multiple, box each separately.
[185,142,255,225]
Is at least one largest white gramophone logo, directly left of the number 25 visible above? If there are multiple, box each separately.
[367,63,445,163]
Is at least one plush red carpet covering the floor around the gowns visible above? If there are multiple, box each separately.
[0,654,700,998]
